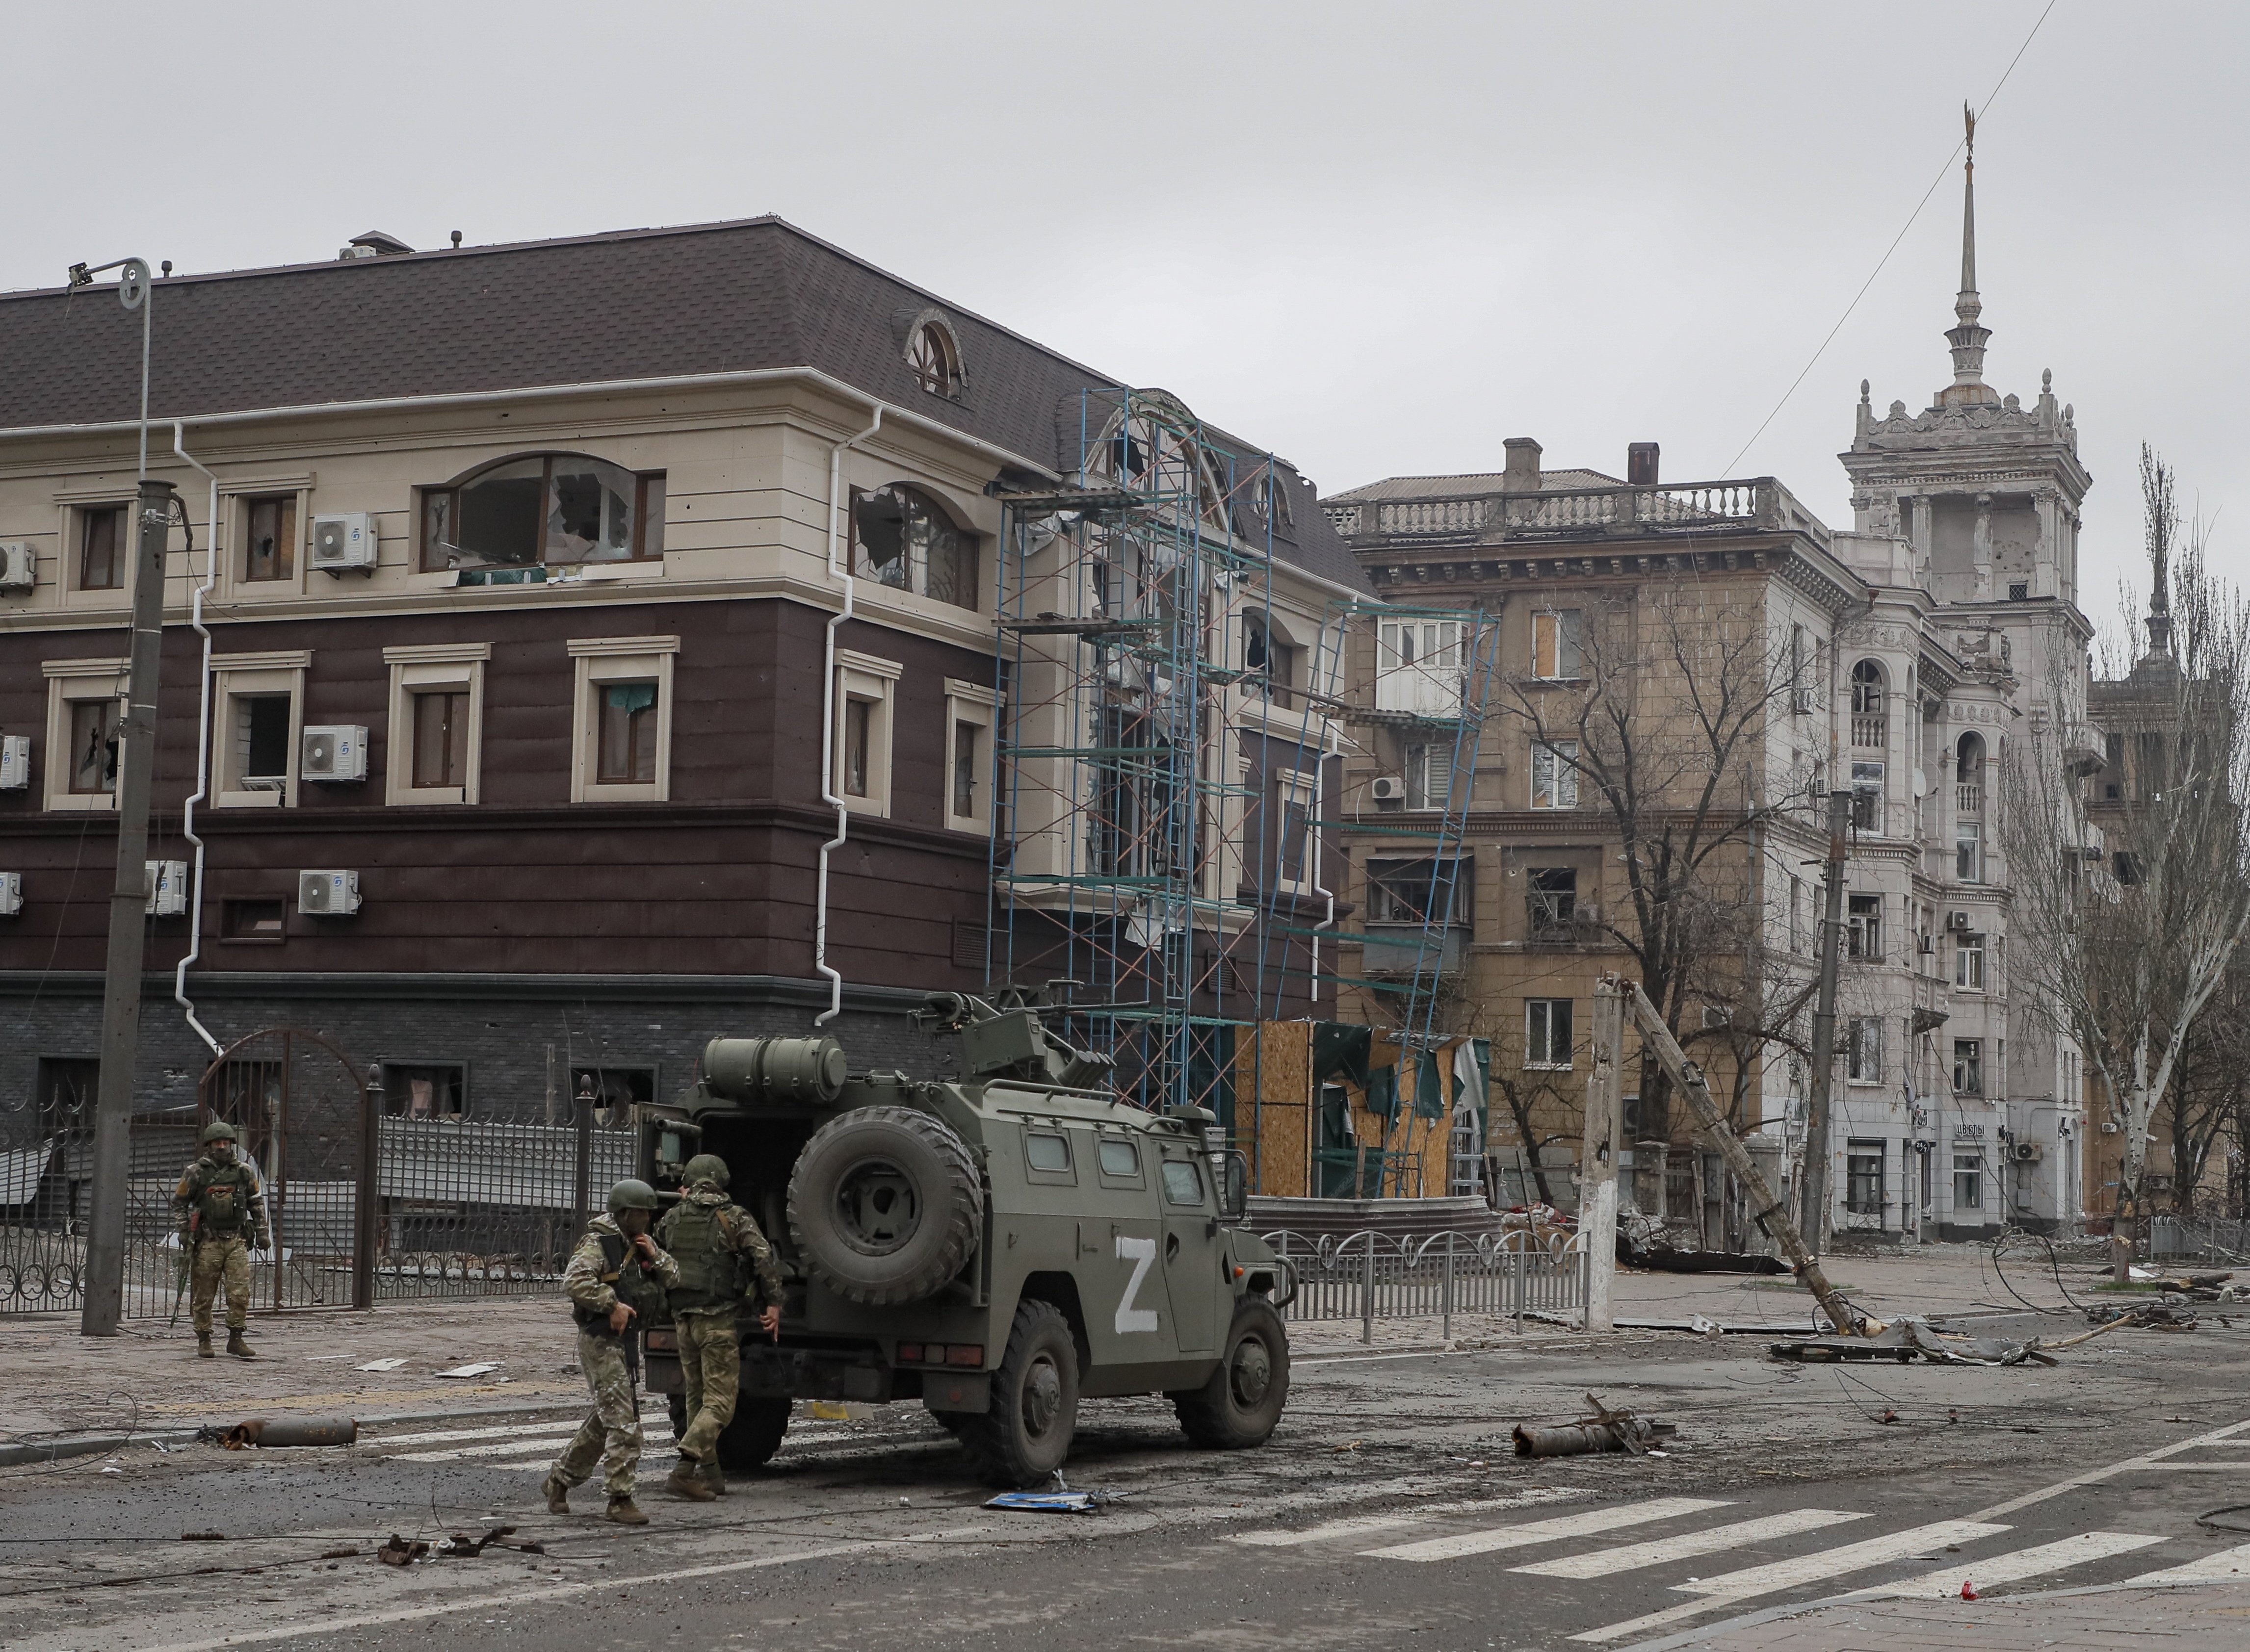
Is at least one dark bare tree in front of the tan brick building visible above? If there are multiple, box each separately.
[1490,578,1805,1139]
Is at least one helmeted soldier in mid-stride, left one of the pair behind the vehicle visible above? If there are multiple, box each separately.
[540,1177,680,1526]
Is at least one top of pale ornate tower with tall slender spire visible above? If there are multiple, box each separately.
[1838,110,2093,605]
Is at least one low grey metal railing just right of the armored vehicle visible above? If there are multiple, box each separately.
[1264,1229,1586,1342]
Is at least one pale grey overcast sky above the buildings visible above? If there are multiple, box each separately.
[0,0,2250,619]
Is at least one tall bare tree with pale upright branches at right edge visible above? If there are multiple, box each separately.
[1998,448,2250,1278]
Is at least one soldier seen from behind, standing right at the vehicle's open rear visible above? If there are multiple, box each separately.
[657,1152,781,1503]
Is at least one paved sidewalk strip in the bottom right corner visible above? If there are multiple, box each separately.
[1692,1582,2250,1652]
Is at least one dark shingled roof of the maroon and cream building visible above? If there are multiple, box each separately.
[0,218,1370,592]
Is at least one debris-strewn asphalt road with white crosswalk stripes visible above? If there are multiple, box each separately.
[0,1321,2250,1652]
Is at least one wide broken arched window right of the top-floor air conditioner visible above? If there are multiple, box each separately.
[421,452,664,585]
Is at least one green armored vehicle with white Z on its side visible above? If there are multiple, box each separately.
[641,993,1294,1485]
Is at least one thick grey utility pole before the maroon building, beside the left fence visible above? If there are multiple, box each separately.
[79,475,173,1337]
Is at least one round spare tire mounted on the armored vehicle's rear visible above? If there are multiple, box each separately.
[790,1108,983,1308]
